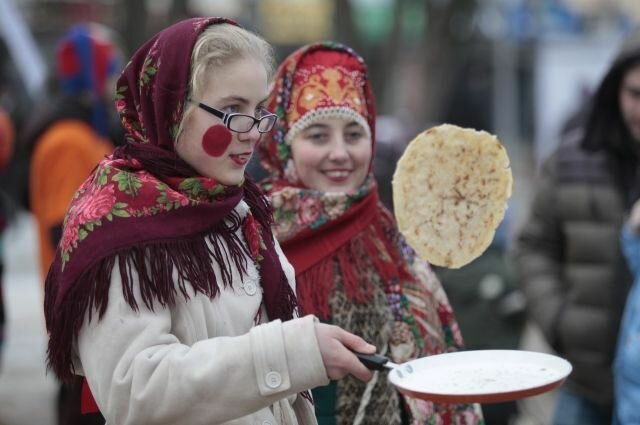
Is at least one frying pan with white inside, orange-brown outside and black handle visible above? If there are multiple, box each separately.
[355,350,572,403]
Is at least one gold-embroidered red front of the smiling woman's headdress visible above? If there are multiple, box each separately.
[287,66,367,126]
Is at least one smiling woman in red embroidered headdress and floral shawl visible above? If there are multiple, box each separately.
[259,42,483,425]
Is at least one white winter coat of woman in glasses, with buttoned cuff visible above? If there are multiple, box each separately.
[75,202,329,425]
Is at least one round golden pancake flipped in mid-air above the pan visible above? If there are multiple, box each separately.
[392,124,513,269]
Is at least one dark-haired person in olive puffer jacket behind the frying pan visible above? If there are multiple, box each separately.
[513,28,640,425]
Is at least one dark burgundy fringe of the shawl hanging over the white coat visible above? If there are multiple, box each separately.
[45,213,254,382]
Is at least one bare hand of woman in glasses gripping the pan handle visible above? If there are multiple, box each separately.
[316,323,376,382]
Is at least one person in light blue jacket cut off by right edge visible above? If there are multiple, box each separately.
[612,198,640,425]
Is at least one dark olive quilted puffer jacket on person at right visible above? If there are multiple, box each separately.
[514,137,631,407]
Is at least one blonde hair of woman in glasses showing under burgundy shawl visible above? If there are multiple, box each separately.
[176,24,275,138]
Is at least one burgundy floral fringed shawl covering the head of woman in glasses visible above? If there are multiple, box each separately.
[45,18,296,380]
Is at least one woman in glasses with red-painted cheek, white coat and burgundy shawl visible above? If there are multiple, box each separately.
[45,18,375,425]
